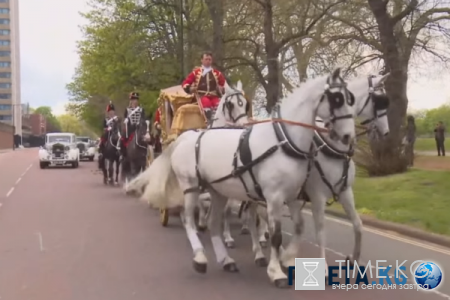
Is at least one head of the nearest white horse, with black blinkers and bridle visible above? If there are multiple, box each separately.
[317,68,355,145]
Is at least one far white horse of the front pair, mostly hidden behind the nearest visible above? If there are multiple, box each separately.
[239,74,389,275]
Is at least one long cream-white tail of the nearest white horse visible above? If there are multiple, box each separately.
[141,139,184,209]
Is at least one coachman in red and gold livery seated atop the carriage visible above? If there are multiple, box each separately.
[182,52,225,123]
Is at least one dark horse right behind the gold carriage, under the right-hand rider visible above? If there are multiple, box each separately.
[121,118,150,182]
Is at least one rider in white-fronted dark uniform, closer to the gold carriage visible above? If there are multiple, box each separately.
[120,92,145,157]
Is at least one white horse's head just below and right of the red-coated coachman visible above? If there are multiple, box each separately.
[213,80,250,127]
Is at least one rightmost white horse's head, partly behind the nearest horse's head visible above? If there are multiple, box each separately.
[348,73,390,136]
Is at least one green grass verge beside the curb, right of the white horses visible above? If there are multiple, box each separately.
[330,169,450,235]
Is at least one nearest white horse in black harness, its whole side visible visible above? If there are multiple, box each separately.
[146,69,355,287]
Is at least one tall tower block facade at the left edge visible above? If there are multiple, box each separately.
[0,0,22,135]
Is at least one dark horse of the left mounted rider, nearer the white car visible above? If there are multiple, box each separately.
[100,120,120,185]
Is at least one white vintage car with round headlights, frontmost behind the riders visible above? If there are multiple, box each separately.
[39,132,80,169]
